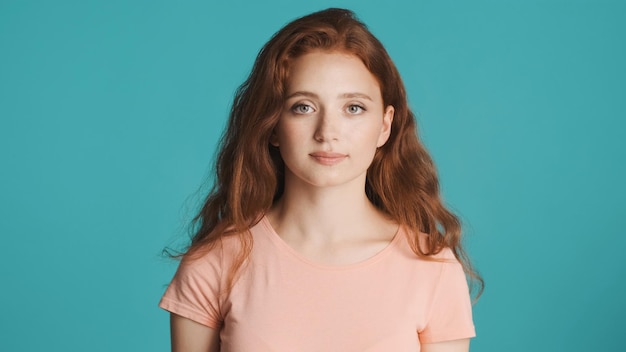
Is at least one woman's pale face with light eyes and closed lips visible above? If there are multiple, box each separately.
[271,51,394,187]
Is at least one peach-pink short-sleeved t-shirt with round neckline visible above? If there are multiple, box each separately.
[159,218,475,352]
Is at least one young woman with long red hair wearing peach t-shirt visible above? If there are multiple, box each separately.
[160,9,482,352]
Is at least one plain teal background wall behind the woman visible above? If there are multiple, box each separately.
[0,0,626,352]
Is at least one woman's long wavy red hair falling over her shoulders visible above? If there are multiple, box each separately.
[184,8,484,295]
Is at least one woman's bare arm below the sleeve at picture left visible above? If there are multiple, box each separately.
[170,313,220,352]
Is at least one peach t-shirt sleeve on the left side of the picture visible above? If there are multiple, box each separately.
[159,246,222,329]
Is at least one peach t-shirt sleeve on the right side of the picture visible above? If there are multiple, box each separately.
[418,260,476,343]
